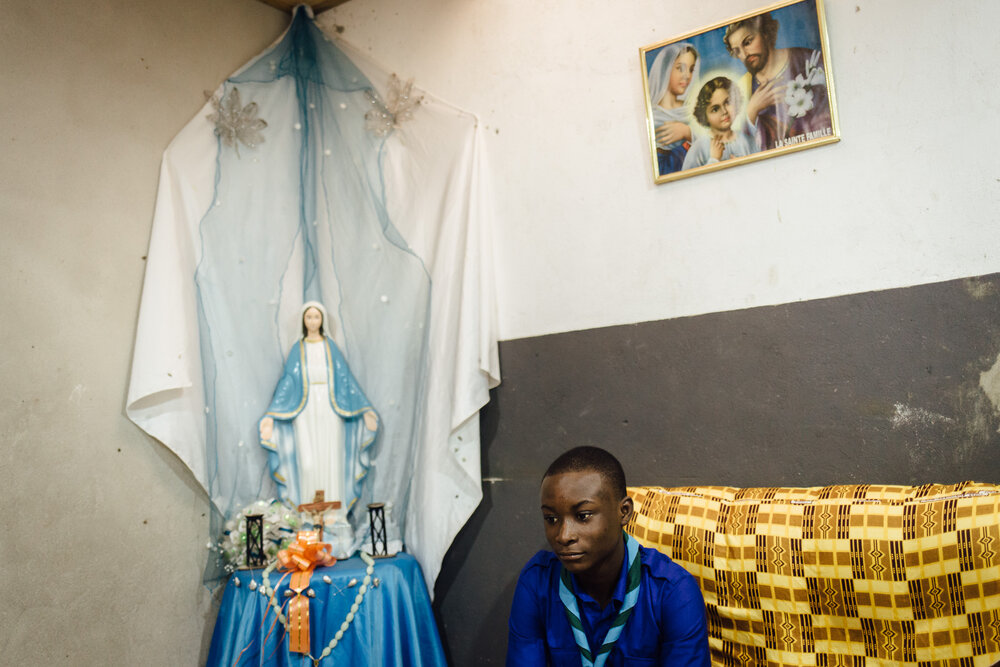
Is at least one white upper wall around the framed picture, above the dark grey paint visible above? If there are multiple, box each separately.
[321,0,1000,339]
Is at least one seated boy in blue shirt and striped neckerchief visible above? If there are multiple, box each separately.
[507,447,710,667]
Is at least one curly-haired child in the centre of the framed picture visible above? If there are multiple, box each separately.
[684,76,760,169]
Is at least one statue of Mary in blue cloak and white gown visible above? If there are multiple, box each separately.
[259,301,378,512]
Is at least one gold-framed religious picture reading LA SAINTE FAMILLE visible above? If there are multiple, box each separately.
[639,0,840,183]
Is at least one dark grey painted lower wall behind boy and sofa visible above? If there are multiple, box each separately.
[435,274,1000,665]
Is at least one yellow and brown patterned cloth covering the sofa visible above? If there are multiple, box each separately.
[626,482,1000,667]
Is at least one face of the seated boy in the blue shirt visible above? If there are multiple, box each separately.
[541,470,632,573]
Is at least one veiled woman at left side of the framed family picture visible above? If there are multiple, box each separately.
[648,42,699,176]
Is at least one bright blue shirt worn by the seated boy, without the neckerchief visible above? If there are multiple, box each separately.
[507,546,711,667]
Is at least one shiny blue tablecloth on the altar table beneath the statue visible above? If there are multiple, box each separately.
[206,553,447,667]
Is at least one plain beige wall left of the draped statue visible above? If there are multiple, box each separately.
[0,0,287,667]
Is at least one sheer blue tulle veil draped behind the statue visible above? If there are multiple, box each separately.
[194,7,431,579]
